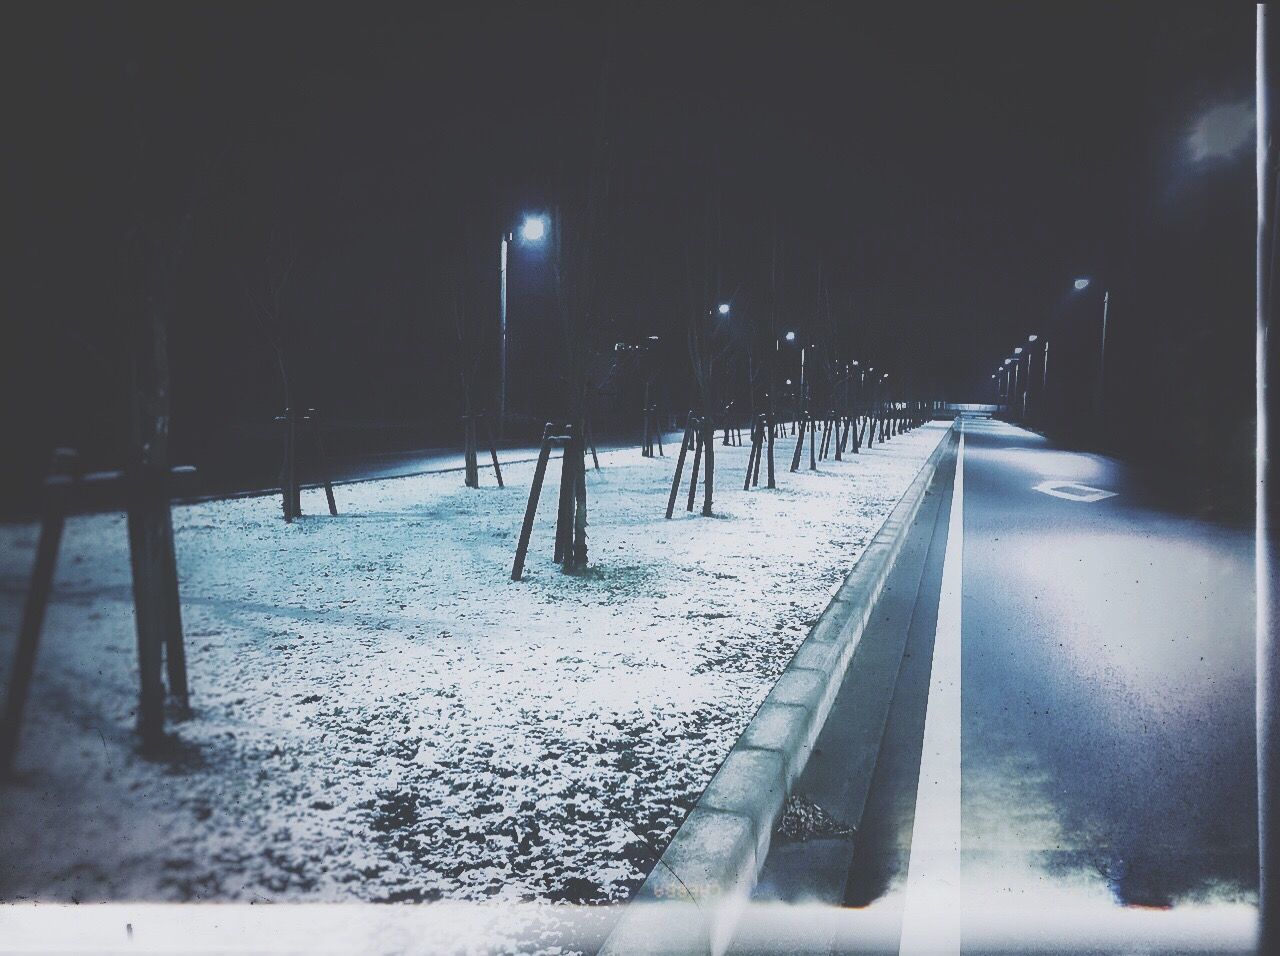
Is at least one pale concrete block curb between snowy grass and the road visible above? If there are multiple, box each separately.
[599,425,957,956]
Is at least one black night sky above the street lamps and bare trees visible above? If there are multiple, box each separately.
[0,3,1253,493]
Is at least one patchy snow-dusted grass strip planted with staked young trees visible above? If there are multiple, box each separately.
[0,424,945,941]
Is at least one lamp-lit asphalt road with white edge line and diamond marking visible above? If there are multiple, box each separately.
[733,421,1257,953]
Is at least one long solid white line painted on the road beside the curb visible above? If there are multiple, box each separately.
[899,427,964,956]
